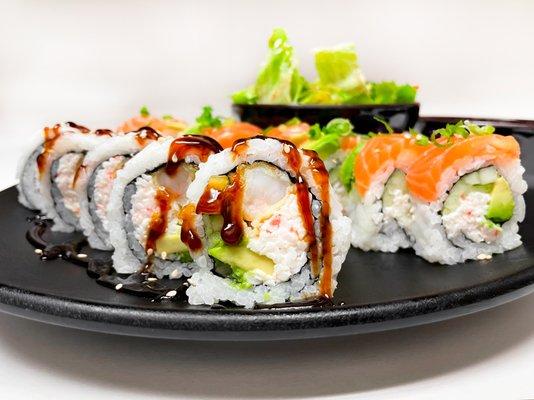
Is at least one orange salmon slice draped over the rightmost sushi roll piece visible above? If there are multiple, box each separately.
[406,135,520,202]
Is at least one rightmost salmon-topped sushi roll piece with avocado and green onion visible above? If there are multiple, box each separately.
[406,128,527,264]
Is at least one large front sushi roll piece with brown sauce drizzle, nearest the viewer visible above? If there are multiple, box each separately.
[182,137,350,308]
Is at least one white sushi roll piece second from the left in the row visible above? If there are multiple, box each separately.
[75,127,161,250]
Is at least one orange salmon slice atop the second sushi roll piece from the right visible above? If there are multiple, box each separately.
[354,133,428,197]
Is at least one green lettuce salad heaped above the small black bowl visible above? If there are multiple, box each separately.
[232,28,417,105]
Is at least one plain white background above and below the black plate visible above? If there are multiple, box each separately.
[0,0,534,399]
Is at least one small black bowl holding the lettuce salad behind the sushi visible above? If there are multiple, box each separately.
[232,103,419,133]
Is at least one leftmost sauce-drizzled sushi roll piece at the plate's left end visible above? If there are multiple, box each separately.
[18,122,112,232]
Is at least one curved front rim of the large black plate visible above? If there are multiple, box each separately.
[0,260,534,340]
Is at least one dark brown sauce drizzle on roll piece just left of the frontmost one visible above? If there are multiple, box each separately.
[145,135,222,260]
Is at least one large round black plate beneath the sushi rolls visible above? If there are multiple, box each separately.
[0,118,534,340]
